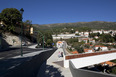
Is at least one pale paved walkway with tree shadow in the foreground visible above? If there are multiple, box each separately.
[37,48,72,77]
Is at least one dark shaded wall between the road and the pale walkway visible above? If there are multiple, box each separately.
[0,49,56,77]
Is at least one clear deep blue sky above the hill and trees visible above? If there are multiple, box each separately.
[0,0,116,24]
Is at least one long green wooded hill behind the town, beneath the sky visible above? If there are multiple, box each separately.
[33,21,116,34]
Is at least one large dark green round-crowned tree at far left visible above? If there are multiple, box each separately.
[0,8,22,31]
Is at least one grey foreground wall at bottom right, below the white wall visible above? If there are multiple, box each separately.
[69,61,116,77]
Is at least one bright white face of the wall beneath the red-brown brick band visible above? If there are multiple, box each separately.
[71,51,116,68]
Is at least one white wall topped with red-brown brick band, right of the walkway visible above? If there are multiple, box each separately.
[64,50,116,69]
